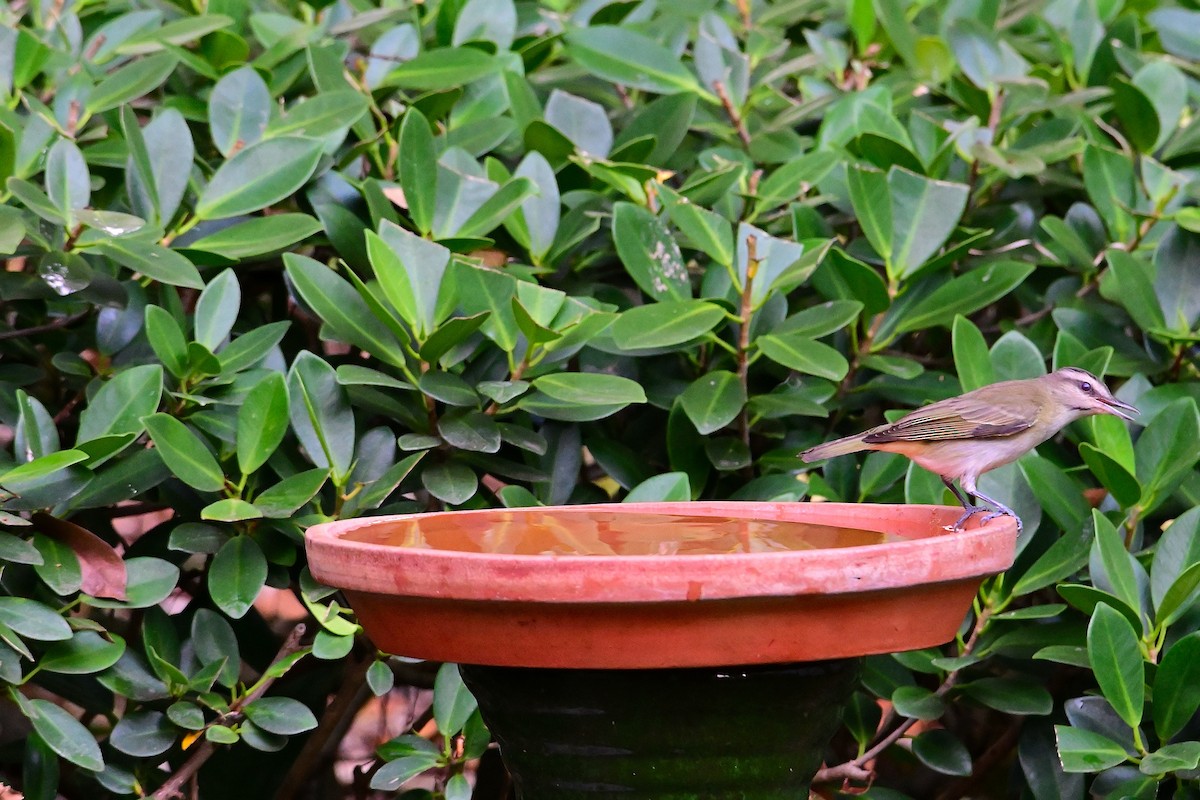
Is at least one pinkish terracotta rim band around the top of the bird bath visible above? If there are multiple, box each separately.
[305,500,1016,603]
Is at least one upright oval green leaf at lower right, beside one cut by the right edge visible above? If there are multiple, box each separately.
[1087,604,1146,727]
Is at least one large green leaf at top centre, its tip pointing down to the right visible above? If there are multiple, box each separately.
[566,25,707,95]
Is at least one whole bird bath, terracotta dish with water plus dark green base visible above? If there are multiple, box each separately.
[307,501,1016,800]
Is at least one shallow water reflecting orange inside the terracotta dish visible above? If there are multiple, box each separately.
[343,509,900,555]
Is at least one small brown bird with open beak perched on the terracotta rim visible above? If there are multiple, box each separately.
[800,367,1138,528]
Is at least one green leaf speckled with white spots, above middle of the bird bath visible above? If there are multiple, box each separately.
[612,203,691,300]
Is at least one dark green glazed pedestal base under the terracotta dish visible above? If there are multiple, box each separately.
[461,658,862,800]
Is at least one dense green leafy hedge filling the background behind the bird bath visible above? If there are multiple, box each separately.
[0,0,1200,800]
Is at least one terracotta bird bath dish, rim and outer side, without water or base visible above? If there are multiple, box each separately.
[306,501,1016,669]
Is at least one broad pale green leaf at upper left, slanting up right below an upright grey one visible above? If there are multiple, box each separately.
[196,137,322,219]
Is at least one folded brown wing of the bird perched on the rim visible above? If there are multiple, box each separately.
[863,396,1034,444]
